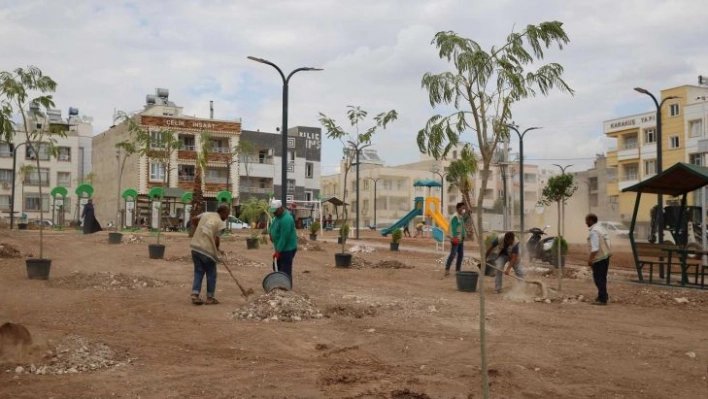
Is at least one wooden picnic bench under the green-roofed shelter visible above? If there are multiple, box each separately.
[634,242,705,286]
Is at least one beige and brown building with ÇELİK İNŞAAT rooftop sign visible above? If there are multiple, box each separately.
[93,89,241,224]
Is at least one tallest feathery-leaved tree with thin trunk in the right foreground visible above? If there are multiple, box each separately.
[418,21,573,398]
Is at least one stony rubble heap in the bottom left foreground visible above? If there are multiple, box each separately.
[5,335,135,375]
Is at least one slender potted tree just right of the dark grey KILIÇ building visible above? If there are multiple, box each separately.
[319,105,398,253]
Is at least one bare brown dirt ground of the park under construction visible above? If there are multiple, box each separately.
[0,231,708,399]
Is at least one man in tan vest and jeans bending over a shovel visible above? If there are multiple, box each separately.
[189,204,231,305]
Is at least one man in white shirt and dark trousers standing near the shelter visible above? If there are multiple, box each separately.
[585,213,612,306]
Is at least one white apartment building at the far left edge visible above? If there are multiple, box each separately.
[0,107,93,224]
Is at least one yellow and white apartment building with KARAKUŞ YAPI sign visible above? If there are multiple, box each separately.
[604,85,708,233]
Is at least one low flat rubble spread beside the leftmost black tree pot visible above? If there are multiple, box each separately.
[47,271,165,291]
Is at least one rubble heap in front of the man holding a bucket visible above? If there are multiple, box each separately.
[232,290,324,322]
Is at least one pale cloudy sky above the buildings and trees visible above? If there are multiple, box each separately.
[0,0,708,174]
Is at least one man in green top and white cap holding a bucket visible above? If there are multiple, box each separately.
[270,199,297,284]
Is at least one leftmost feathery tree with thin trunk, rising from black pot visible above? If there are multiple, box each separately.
[0,66,66,259]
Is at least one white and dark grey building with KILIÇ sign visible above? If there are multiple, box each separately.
[239,126,322,205]
